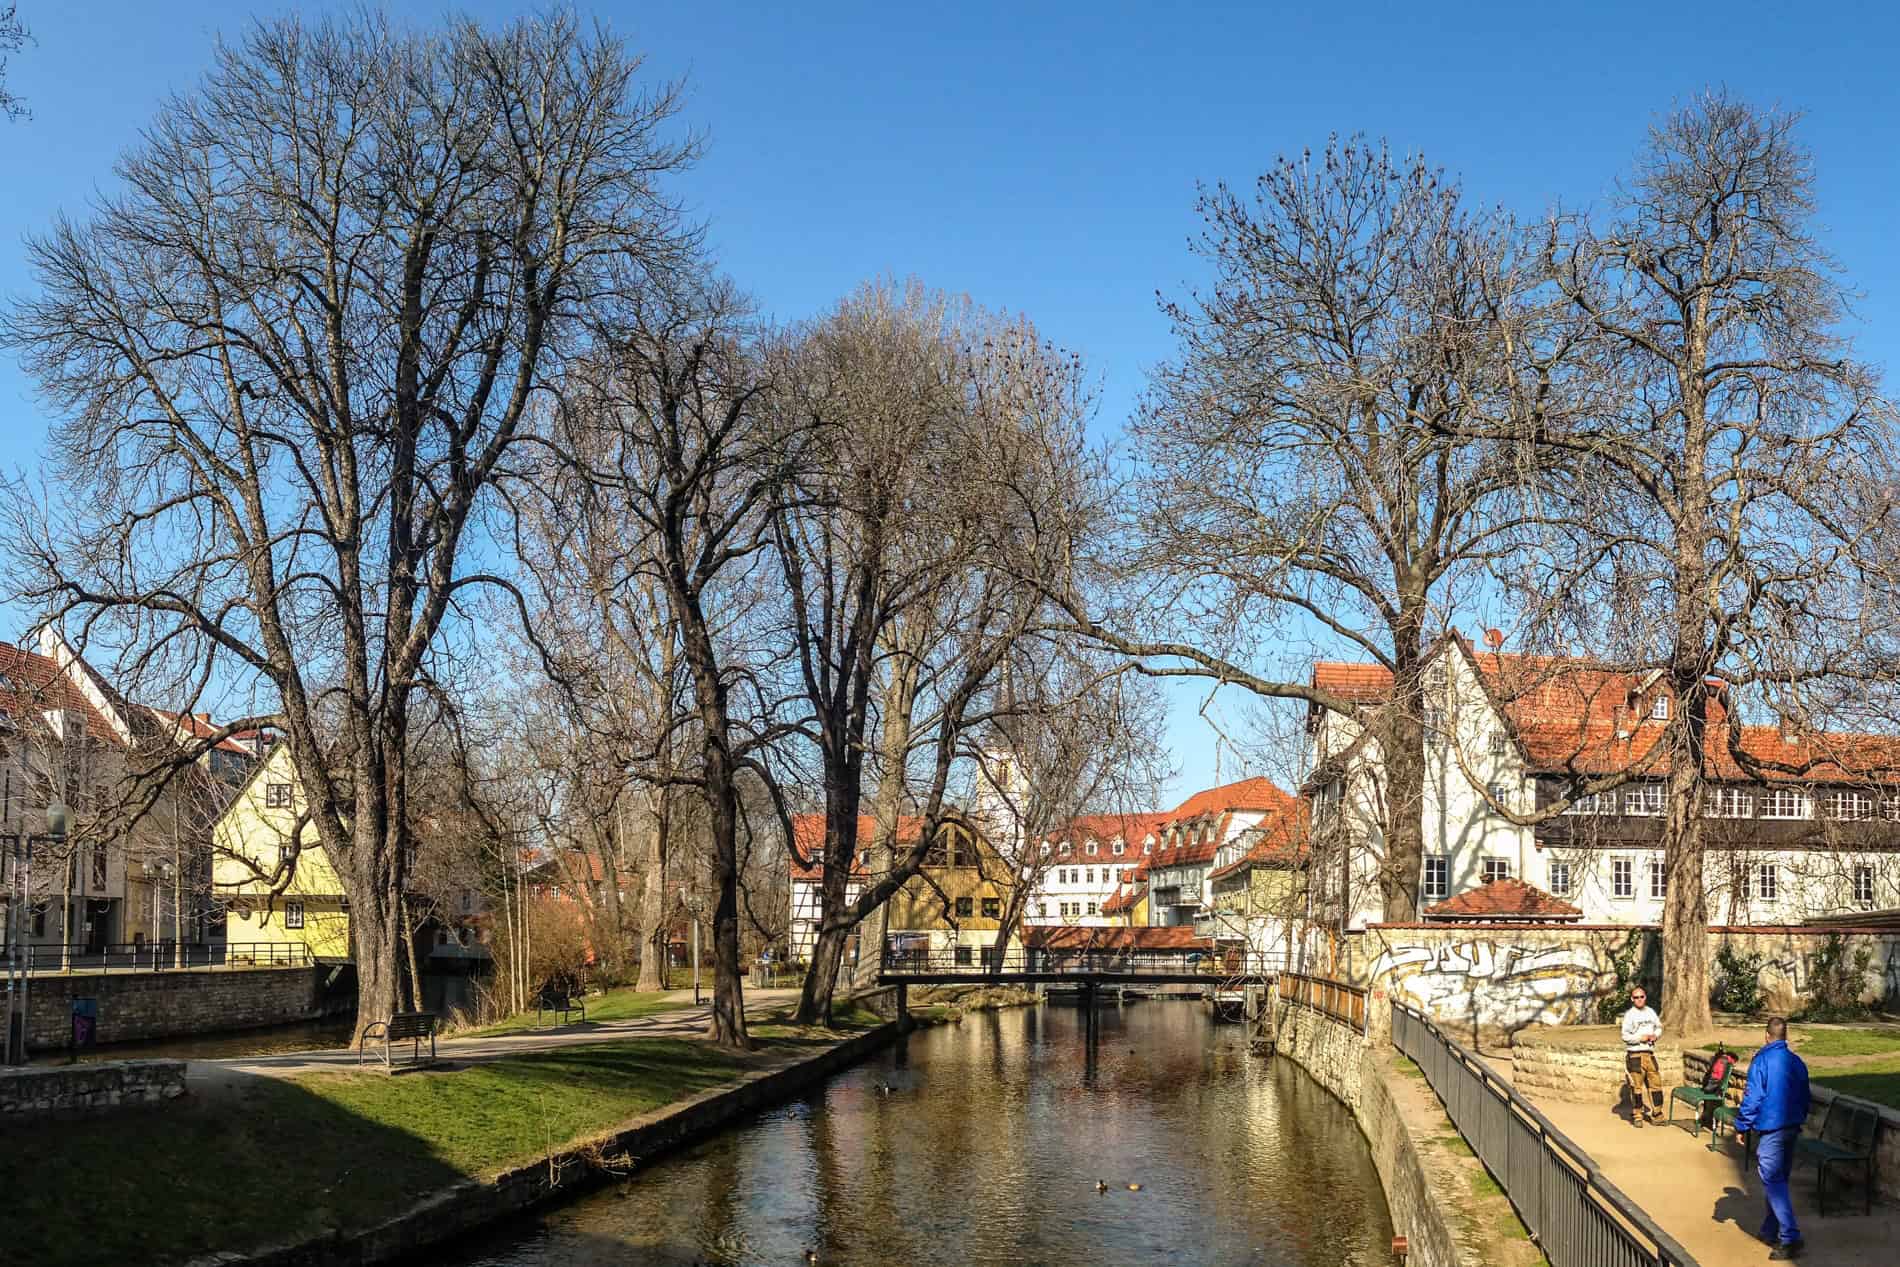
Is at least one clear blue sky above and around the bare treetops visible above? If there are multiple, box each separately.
[0,0,1900,794]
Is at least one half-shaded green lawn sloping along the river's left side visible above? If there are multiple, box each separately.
[0,1039,743,1267]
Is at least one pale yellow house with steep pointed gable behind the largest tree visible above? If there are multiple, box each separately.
[211,745,350,961]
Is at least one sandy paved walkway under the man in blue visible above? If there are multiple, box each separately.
[1527,1094,1900,1267]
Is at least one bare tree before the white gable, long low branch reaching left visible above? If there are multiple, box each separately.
[1066,141,1562,919]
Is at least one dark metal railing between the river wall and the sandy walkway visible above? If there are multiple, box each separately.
[1393,1003,1697,1267]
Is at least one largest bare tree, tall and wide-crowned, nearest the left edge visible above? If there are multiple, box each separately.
[0,13,690,1022]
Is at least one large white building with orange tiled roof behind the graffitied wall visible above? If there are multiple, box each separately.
[1302,634,1900,929]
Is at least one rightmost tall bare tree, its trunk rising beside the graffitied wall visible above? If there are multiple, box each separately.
[1535,93,1894,1033]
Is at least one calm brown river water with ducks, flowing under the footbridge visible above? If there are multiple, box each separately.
[439,1001,1393,1267]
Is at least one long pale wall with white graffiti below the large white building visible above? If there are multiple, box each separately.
[1347,923,1900,1037]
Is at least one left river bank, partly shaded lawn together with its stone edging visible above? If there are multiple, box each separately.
[0,1011,895,1267]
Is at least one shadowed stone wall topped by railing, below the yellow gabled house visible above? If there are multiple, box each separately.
[27,965,355,1052]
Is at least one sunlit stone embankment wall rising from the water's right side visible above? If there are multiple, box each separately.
[1275,1003,1486,1267]
